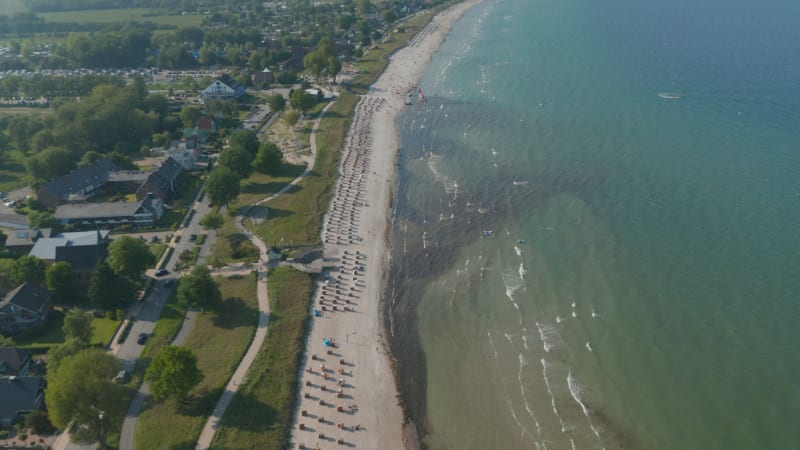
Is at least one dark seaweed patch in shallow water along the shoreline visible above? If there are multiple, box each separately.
[384,98,608,448]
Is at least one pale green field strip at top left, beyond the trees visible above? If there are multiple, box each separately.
[39,8,203,28]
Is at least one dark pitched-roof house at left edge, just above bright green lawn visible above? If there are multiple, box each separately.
[0,282,53,334]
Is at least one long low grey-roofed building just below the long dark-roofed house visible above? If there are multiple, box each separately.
[54,193,164,228]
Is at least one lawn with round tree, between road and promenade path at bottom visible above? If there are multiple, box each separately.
[136,276,258,450]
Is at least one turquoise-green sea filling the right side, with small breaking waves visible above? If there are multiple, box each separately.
[388,0,800,450]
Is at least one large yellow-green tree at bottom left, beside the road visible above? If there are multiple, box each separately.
[45,348,122,442]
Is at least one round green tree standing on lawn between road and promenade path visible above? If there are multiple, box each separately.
[145,346,203,400]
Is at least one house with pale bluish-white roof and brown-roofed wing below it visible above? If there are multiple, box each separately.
[29,230,109,286]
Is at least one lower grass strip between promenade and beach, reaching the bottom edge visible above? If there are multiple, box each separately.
[211,267,312,450]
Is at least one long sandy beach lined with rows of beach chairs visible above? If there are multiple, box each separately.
[292,0,479,450]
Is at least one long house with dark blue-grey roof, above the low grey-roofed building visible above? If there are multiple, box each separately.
[38,159,119,209]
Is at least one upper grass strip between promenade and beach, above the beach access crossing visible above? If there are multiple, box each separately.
[252,94,358,248]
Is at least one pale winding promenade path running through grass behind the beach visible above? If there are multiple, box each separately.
[195,102,333,450]
